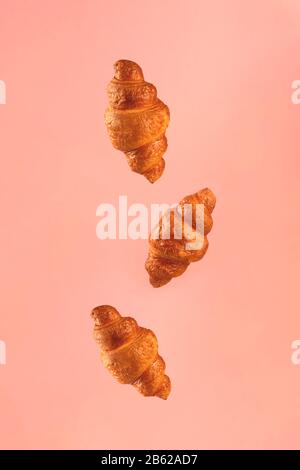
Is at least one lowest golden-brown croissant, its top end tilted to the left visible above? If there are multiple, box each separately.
[91,305,171,400]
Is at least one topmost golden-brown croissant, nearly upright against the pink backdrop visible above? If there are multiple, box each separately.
[105,60,170,183]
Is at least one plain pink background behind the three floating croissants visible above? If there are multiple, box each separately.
[0,0,300,449]
